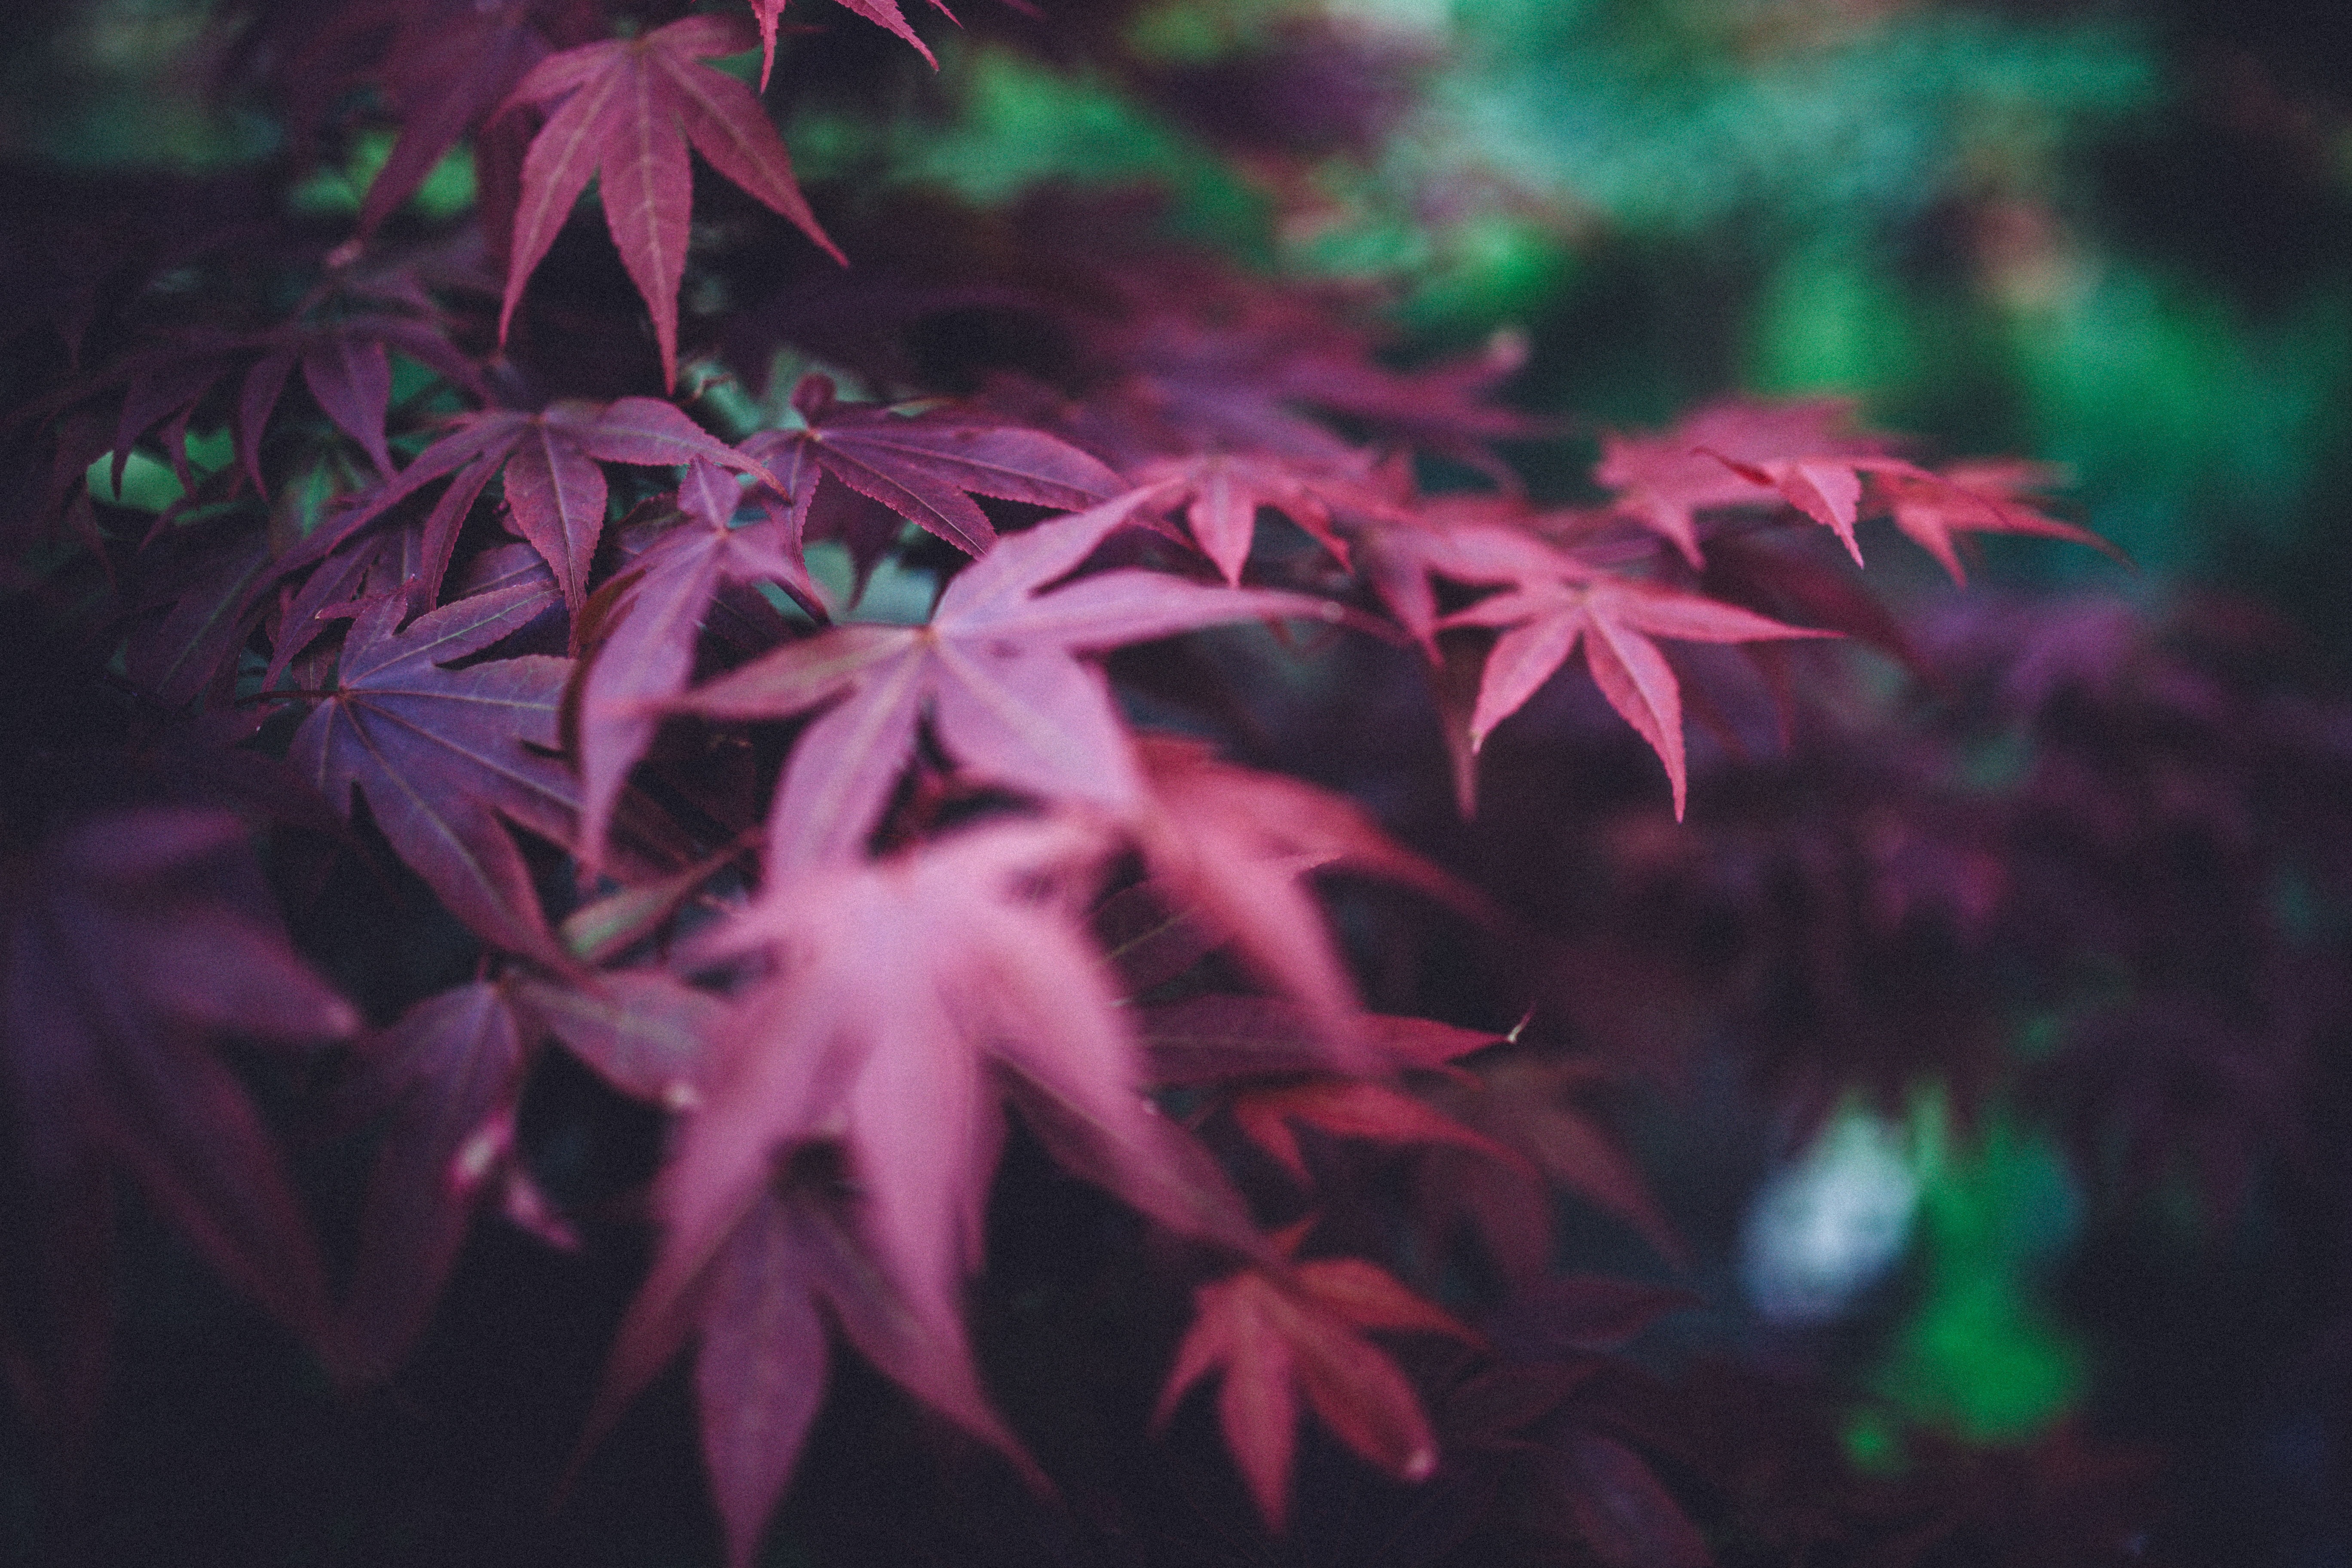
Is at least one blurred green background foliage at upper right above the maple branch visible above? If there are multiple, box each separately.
[896,0,2352,602]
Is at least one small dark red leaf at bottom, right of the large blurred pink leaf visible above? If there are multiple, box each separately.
[1152,1225,1477,1530]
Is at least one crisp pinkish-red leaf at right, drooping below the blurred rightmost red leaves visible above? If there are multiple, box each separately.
[1439,574,1834,821]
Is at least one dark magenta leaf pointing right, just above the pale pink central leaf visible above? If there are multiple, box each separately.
[743,376,1127,555]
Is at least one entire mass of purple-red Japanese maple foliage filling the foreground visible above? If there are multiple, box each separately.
[0,0,2295,1568]
